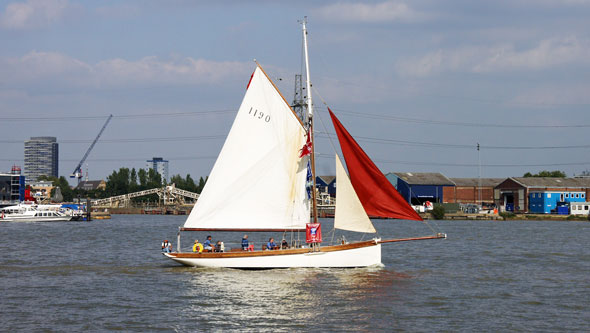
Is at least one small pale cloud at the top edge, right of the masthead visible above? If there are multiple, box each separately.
[317,1,426,22]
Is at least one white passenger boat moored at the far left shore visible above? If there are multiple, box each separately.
[0,203,72,222]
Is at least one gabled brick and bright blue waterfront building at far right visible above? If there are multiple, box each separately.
[494,177,590,214]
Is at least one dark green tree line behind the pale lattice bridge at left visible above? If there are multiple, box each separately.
[39,168,207,202]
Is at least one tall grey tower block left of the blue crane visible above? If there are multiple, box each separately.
[24,136,59,184]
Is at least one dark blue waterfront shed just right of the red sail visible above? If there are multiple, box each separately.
[394,172,455,205]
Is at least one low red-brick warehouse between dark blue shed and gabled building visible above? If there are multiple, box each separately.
[443,178,506,205]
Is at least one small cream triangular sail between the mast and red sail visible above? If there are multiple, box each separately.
[334,155,377,233]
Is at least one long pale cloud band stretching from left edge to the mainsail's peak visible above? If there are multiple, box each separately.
[0,51,253,87]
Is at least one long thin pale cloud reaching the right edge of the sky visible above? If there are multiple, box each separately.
[396,37,590,76]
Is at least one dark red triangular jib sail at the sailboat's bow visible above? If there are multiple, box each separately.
[328,108,422,221]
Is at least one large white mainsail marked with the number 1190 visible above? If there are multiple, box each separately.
[184,66,310,230]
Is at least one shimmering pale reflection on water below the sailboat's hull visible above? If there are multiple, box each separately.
[177,267,412,329]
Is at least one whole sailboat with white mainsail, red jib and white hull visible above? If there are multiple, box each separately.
[163,20,446,269]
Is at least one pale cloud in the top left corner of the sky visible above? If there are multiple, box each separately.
[0,0,70,30]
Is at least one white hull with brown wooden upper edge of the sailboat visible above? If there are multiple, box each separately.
[164,240,381,269]
